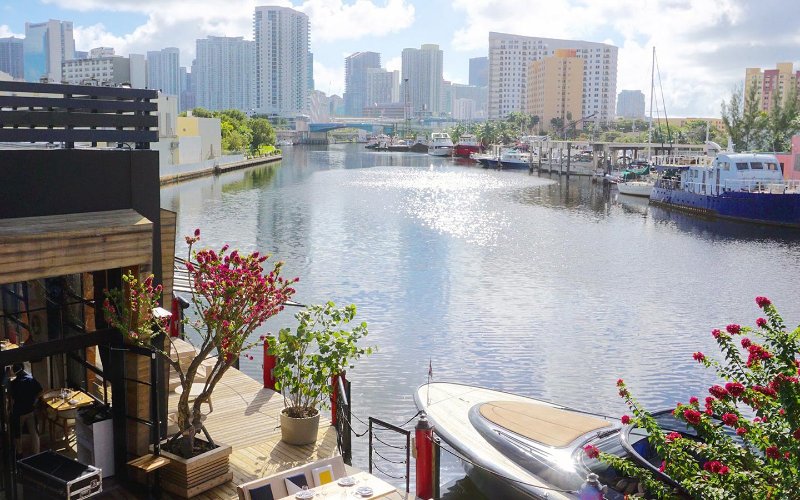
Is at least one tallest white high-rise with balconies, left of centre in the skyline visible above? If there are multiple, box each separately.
[253,6,313,117]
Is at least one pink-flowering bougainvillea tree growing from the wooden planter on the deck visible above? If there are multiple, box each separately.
[104,229,298,455]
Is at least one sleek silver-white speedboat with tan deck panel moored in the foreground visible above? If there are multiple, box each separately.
[414,382,685,500]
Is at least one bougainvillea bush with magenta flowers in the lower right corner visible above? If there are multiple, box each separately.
[586,297,800,499]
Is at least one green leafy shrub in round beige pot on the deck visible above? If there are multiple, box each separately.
[269,302,372,445]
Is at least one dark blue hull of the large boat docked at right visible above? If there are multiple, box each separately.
[650,186,800,228]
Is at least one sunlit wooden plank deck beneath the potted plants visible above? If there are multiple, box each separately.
[99,368,340,500]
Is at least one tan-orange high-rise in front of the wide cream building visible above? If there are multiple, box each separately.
[525,49,583,133]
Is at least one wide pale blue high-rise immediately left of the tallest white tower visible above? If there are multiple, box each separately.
[192,36,255,113]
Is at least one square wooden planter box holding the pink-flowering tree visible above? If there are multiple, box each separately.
[155,438,233,498]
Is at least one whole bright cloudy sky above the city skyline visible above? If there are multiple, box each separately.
[0,0,800,117]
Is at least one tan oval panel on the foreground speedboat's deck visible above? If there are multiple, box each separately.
[480,401,611,448]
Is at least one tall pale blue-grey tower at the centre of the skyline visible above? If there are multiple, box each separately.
[400,44,444,117]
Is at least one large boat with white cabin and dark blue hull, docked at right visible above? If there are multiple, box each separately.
[650,153,800,228]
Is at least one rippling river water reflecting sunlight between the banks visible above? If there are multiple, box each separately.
[161,144,800,497]
